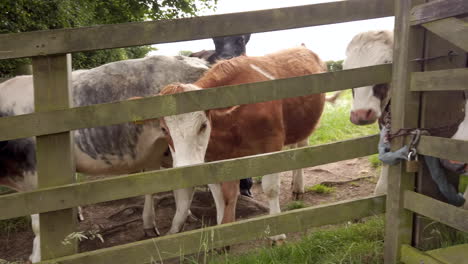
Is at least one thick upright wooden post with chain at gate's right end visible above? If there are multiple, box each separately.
[384,0,424,264]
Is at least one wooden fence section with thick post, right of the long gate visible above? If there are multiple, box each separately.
[385,0,468,264]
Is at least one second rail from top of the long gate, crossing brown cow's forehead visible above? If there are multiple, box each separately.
[0,64,392,141]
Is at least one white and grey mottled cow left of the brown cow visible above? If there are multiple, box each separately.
[0,56,208,262]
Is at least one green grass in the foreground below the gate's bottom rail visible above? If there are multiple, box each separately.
[206,217,384,264]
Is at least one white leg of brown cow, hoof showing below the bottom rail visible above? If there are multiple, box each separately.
[262,173,286,243]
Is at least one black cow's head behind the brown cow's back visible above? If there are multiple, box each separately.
[213,34,250,60]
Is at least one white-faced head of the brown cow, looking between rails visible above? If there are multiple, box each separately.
[160,84,222,167]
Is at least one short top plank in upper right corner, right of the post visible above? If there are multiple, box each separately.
[411,0,468,25]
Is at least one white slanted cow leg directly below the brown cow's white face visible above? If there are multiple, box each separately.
[167,187,194,234]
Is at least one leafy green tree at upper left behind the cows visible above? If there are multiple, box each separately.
[0,0,217,77]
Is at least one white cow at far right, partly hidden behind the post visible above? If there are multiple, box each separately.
[343,30,468,207]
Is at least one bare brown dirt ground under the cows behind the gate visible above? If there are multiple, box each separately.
[0,157,378,263]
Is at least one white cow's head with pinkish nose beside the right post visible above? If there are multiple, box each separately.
[343,31,393,125]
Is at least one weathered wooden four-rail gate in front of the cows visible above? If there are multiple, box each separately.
[0,0,468,263]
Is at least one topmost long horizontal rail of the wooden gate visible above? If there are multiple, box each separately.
[0,0,393,59]
